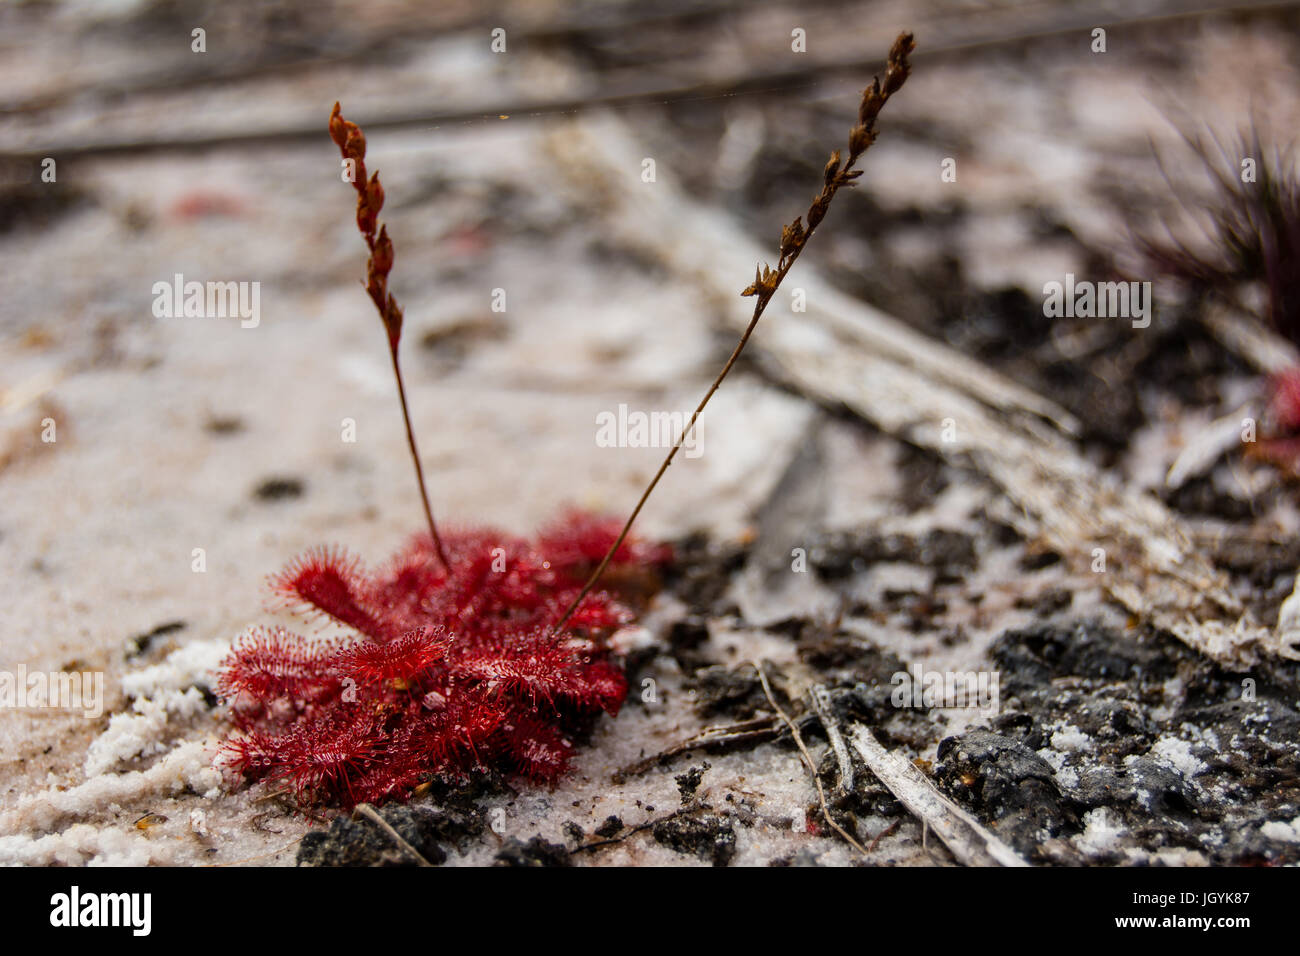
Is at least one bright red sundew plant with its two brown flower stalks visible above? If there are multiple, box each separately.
[217,34,914,808]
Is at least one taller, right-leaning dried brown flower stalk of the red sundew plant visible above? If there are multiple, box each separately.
[553,33,917,632]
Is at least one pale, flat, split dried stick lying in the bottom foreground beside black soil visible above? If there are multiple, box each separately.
[849,723,1028,866]
